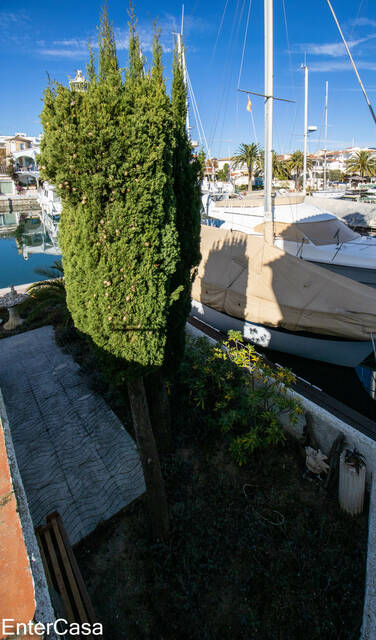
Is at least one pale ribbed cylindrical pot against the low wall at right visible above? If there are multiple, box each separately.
[338,451,366,516]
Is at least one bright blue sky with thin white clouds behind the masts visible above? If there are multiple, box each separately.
[0,0,376,157]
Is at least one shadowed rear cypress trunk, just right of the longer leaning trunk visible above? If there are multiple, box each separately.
[145,371,173,455]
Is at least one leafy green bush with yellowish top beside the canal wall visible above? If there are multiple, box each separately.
[175,331,302,465]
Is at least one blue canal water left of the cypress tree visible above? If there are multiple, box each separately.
[0,214,60,289]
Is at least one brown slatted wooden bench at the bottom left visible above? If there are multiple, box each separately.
[35,511,97,638]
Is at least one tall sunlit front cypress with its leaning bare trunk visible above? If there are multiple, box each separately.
[40,12,179,537]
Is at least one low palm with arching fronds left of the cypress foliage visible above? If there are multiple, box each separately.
[28,260,71,326]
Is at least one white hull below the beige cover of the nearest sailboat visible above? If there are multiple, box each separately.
[192,300,372,367]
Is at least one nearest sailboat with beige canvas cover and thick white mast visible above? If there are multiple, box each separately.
[192,0,376,367]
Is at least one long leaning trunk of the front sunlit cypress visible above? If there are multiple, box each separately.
[127,378,169,540]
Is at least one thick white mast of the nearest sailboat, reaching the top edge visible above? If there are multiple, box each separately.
[264,0,274,244]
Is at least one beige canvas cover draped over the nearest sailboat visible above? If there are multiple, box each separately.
[192,225,376,340]
